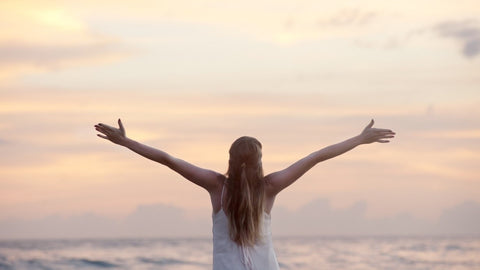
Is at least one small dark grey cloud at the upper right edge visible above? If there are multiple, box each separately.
[434,20,480,58]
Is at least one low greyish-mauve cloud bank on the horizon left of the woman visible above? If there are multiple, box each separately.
[0,204,211,238]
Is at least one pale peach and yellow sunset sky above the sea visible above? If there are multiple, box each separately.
[0,0,480,237]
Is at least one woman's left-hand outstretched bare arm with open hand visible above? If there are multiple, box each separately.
[95,119,222,192]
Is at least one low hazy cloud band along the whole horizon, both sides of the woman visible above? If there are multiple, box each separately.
[0,199,480,238]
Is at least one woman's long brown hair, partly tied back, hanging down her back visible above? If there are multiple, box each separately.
[225,136,265,246]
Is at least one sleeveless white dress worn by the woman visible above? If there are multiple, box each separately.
[212,185,280,270]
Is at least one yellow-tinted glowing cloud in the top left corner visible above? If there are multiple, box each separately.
[0,2,129,81]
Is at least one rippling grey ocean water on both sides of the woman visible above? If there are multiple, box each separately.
[0,236,480,270]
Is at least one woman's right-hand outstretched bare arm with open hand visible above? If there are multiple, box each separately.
[265,119,395,196]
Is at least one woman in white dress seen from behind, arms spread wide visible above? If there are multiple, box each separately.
[95,119,395,270]
